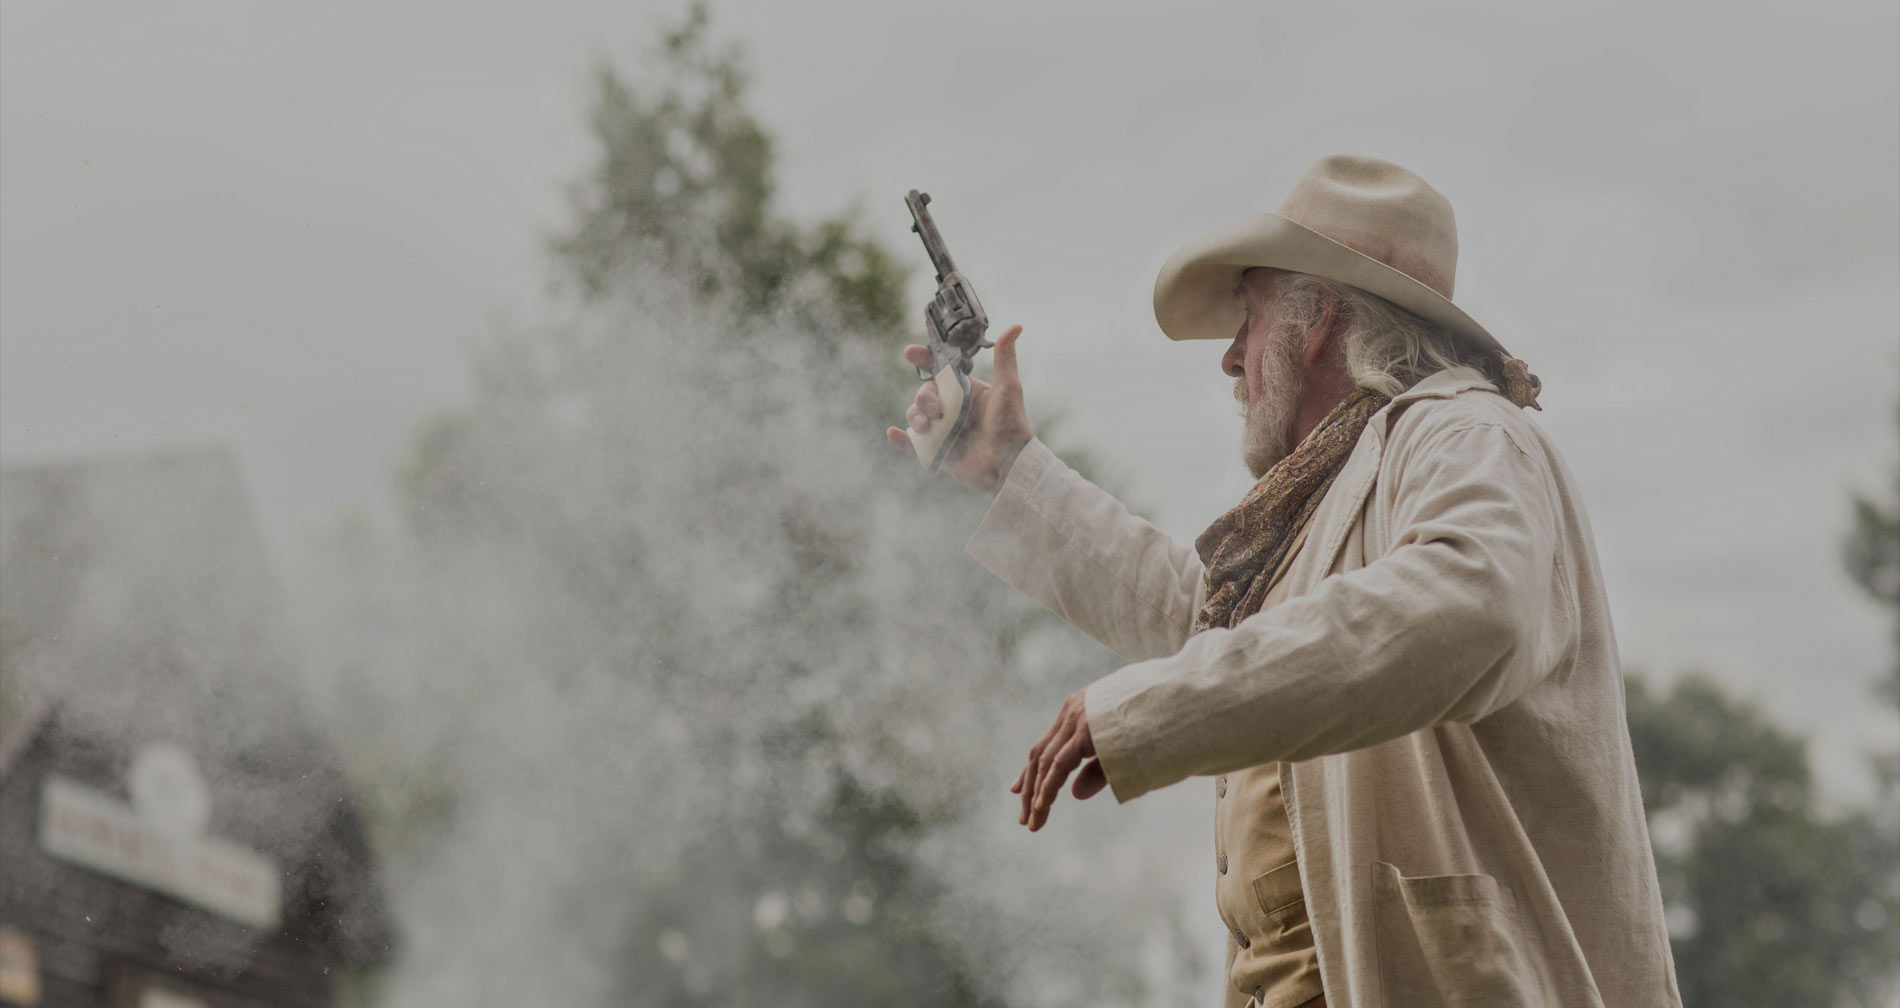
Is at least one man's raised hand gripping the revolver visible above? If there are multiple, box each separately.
[884,325,1036,497]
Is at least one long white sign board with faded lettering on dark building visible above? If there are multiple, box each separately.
[40,775,283,930]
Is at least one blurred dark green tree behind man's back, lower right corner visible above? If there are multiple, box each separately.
[1628,676,1900,1008]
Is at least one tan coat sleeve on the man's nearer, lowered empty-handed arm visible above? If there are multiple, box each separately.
[1087,413,1575,801]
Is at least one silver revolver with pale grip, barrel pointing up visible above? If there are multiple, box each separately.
[904,190,996,473]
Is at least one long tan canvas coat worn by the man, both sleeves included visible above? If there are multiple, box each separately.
[969,368,1682,1008]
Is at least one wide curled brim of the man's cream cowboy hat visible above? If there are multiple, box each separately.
[1155,213,1505,351]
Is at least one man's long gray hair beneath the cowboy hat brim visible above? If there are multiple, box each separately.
[1243,270,1495,395]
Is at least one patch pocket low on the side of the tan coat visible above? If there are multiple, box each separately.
[1372,862,1549,1008]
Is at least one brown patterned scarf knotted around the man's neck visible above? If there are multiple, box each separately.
[1193,353,1543,634]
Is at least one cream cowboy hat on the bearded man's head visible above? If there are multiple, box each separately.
[1155,154,1505,351]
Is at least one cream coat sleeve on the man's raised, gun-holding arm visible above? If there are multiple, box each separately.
[969,440,1201,661]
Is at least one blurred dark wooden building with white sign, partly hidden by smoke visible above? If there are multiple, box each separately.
[0,452,391,1008]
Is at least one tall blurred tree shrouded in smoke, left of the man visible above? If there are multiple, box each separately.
[349,4,1169,1008]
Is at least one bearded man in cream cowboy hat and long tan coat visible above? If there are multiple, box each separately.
[887,156,1680,1008]
